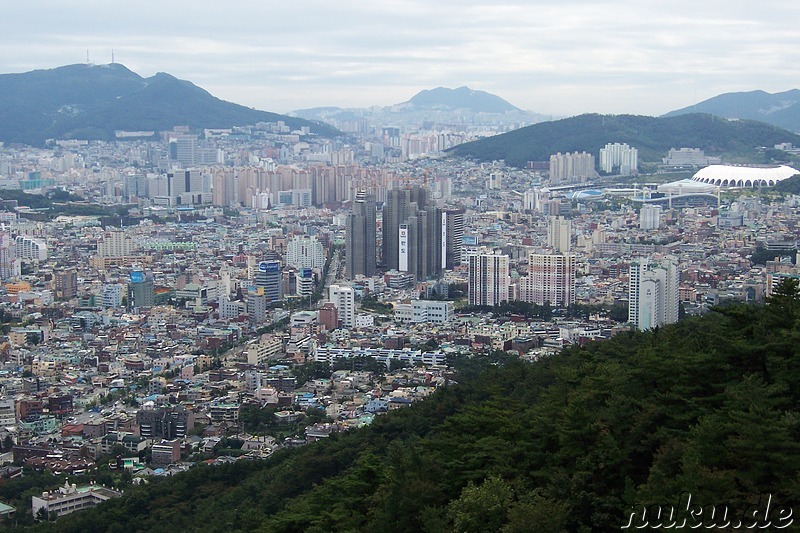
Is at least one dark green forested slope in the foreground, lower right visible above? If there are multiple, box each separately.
[20,282,800,532]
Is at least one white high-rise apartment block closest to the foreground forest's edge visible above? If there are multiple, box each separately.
[628,257,680,330]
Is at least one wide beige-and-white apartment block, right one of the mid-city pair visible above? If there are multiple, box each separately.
[520,254,576,307]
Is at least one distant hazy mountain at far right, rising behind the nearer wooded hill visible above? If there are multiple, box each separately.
[664,89,800,132]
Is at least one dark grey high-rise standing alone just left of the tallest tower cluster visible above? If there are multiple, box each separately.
[345,191,377,279]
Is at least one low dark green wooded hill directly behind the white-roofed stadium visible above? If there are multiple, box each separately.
[449,114,800,167]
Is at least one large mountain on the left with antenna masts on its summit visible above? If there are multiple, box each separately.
[0,63,337,145]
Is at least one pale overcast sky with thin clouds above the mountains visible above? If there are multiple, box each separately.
[0,0,800,116]
